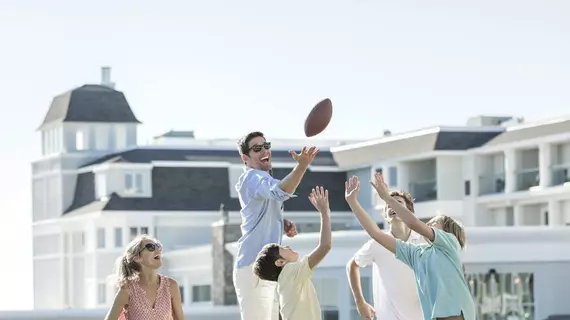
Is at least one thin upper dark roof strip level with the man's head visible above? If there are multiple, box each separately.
[83,147,337,167]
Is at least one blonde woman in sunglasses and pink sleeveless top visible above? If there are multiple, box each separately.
[105,235,184,320]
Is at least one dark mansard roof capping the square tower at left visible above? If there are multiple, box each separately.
[39,85,141,129]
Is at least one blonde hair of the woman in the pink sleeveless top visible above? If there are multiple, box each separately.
[115,234,156,288]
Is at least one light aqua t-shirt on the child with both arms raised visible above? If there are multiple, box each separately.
[396,228,475,320]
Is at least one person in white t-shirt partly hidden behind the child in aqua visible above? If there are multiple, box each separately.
[346,190,425,320]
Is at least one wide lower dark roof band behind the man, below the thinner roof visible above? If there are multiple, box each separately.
[64,167,349,215]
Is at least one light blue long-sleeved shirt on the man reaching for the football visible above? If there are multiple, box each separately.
[235,168,293,268]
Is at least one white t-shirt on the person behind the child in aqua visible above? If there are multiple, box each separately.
[354,231,426,320]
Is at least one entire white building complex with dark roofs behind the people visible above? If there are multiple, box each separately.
[14,69,570,320]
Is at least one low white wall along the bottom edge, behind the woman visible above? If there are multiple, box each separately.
[0,306,240,320]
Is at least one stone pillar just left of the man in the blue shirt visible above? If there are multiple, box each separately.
[212,203,241,306]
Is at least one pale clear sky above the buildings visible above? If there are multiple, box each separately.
[0,0,570,309]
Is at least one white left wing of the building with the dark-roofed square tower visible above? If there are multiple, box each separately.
[32,68,352,309]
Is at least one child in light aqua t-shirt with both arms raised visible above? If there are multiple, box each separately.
[345,173,475,320]
